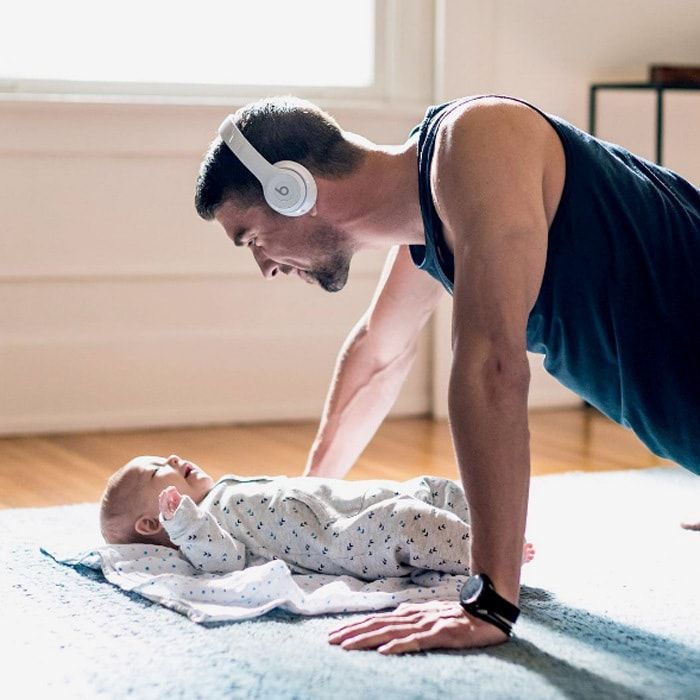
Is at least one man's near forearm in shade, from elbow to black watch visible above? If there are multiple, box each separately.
[449,370,530,602]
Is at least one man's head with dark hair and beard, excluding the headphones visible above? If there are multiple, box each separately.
[195,97,365,292]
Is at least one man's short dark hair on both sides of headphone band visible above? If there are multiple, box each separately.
[194,97,364,219]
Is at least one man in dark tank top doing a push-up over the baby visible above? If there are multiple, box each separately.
[196,96,700,653]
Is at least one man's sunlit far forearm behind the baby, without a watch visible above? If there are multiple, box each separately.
[305,324,415,478]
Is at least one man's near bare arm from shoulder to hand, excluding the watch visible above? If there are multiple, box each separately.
[330,101,551,653]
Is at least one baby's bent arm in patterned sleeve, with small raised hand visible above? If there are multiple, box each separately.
[159,486,245,573]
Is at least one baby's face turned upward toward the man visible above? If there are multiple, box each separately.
[128,455,214,513]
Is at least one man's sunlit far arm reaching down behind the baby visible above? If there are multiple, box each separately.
[304,246,442,477]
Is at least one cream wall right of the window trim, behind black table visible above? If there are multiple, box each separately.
[433,0,700,416]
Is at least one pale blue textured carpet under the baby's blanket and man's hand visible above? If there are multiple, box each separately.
[0,468,700,700]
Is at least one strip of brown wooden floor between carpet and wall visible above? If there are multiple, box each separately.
[0,409,664,508]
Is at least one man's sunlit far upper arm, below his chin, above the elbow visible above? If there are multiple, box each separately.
[365,246,444,360]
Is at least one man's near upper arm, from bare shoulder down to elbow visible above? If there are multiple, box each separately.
[437,102,548,363]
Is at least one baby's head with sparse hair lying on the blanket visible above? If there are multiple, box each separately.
[100,455,214,545]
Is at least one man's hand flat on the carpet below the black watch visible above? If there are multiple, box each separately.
[328,601,507,654]
